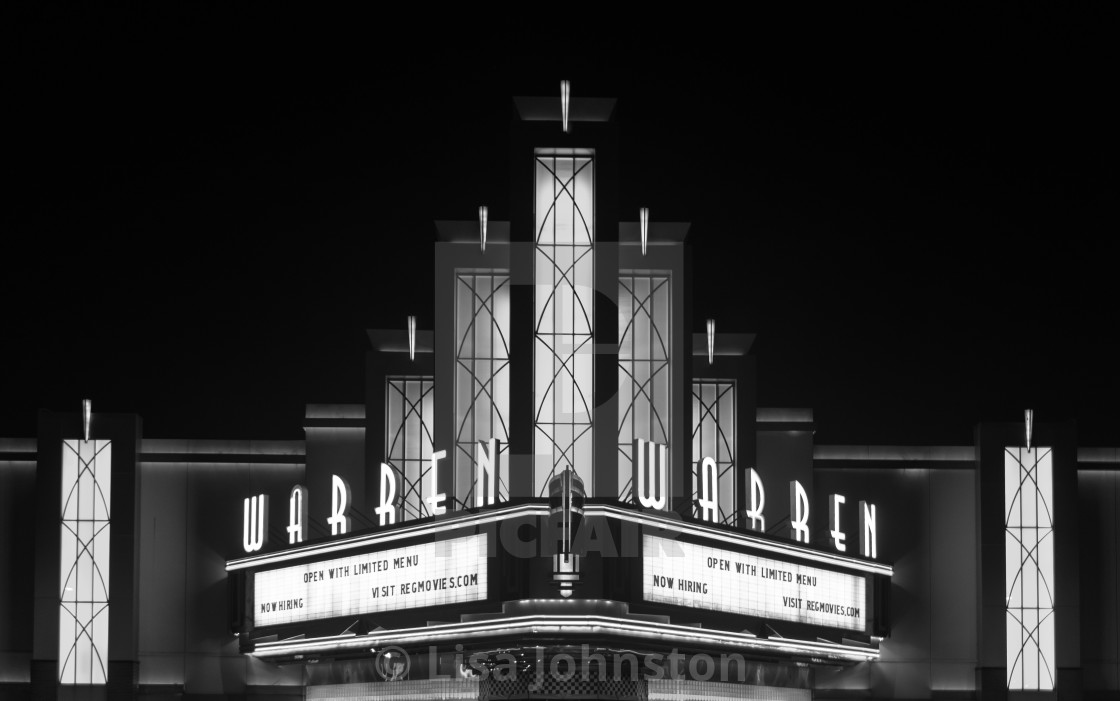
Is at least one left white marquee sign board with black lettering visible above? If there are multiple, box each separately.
[253,535,487,626]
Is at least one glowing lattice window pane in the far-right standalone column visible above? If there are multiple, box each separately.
[1004,448,1057,691]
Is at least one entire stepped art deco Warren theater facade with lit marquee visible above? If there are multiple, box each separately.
[0,88,1120,700]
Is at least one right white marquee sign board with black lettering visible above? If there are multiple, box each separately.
[642,535,867,630]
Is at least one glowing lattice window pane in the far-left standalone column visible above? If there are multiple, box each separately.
[58,440,113,684]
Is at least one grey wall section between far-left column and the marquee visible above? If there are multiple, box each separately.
[139,441,304,694]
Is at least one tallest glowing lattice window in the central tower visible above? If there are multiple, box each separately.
[533,153,595,496]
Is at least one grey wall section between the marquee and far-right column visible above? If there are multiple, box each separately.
[810,462,978,699]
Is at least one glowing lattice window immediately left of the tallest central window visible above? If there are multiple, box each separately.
[455,272,510,508]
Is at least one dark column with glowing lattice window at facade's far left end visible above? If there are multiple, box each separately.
[34,408,141,699]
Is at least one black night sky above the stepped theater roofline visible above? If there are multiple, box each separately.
[0,2,1120,446]
